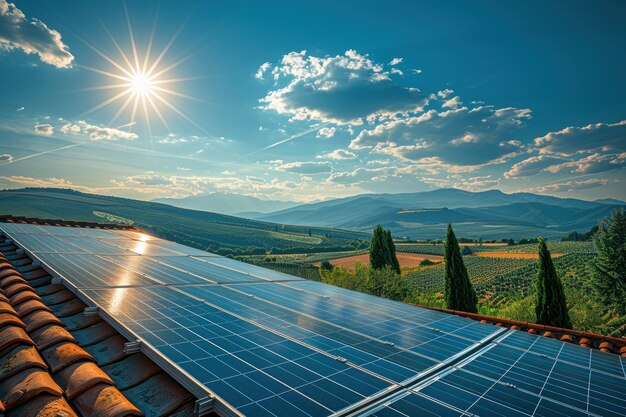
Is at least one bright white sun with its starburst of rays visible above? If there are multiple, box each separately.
[78,5,204,137]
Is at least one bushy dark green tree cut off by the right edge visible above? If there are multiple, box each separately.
[592,209,626,314]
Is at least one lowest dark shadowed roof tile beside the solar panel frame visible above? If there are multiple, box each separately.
[124,373,193,416]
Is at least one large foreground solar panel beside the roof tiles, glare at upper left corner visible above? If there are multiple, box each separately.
[80,287,391,416]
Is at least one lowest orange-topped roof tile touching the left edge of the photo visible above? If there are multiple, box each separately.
[0,368,63,409]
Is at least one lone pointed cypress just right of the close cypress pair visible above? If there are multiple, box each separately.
[443,224,478,313]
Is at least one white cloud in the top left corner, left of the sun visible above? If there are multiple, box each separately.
[0,0,74,68]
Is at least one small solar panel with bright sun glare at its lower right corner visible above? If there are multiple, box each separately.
[37,253,158,288]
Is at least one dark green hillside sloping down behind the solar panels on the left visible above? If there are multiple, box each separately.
[0,188,368,254]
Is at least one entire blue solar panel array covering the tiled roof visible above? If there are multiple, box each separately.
[0,224,626,417]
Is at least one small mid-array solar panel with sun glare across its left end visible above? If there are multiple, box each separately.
[102,255,209,285]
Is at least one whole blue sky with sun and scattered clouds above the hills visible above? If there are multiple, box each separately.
[0,0,626,201]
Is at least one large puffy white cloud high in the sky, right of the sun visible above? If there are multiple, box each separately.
[260,50,428,125]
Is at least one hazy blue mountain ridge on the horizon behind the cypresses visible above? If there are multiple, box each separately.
[249,189,626,239]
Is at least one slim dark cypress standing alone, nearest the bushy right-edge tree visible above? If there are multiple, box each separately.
[534,238,572,328]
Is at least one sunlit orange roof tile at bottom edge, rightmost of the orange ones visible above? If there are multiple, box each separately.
[74,384,142,417]
